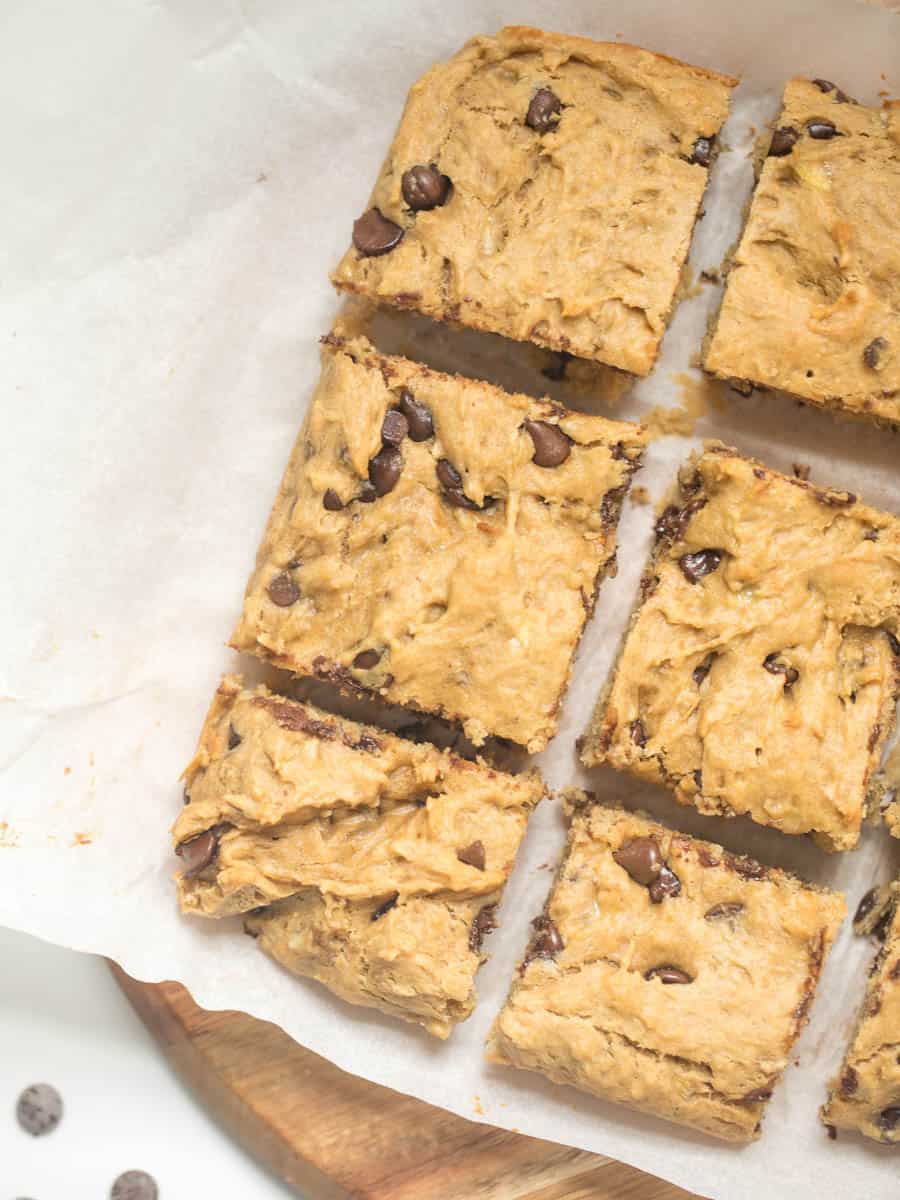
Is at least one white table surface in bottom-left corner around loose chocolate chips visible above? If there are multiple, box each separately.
[0,929,296,1200]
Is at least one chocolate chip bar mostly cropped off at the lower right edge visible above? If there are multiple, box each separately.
[822,882,900,1146]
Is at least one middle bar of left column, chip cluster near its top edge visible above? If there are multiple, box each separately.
[232,336,646,751]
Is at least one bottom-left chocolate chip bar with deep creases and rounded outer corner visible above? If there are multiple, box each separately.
[173,676,544,1038]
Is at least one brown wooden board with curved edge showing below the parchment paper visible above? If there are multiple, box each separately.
[110,964,697,1200]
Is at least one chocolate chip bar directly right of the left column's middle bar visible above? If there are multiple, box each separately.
[582,443,900,850]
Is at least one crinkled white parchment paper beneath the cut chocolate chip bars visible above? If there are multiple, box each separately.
[0,0,900,1200]
